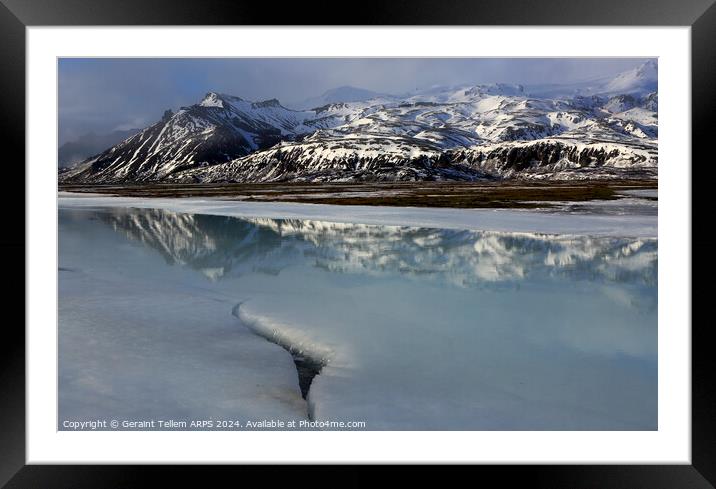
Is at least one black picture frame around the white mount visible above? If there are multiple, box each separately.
[0,0,716,489]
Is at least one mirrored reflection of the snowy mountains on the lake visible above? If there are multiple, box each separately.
[96,209,657,292]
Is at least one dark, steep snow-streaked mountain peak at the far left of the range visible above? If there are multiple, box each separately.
[61,92,313,183]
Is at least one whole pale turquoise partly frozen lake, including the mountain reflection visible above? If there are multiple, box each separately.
[58,204,657,430]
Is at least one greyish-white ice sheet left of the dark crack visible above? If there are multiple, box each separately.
[58,211,306,429]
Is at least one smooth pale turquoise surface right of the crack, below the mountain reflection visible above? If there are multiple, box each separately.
[240,269,656,430]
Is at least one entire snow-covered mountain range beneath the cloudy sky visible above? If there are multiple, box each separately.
[60,61,658,183]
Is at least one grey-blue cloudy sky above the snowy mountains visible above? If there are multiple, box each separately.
[58,58,644,144]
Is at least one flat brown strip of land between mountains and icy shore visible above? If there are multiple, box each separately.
[60,180,658,208]
